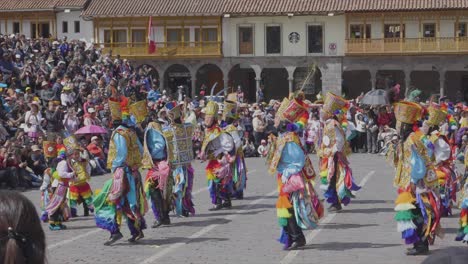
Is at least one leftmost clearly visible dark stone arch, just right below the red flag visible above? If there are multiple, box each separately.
[164,63,192,98]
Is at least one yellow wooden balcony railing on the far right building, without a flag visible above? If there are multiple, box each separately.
[346,37,468,55]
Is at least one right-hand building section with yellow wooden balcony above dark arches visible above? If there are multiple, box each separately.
[343,1,468,100]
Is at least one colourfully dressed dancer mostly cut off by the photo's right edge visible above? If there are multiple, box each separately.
[456,145,468,244]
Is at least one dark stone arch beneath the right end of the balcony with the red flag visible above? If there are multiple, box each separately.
[194,63,223,95]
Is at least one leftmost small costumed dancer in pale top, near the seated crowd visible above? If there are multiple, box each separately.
[46,148,78,231]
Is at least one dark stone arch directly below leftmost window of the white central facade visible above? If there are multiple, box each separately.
[227,63,256,102]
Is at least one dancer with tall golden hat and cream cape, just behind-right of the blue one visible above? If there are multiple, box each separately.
[317,93,360,212]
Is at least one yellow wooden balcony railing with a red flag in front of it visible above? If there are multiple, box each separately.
[97,41,222,59]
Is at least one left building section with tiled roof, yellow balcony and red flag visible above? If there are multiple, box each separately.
[82,0,226,98]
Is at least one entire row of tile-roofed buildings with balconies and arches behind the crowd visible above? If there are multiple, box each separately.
[0,0,468,101]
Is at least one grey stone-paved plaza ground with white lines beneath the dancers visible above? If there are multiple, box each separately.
[19,154,468,264]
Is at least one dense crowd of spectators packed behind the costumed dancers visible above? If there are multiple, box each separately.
[0,34,468,189]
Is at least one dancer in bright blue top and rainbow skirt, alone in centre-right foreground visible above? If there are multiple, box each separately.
[269,96,323,250]
